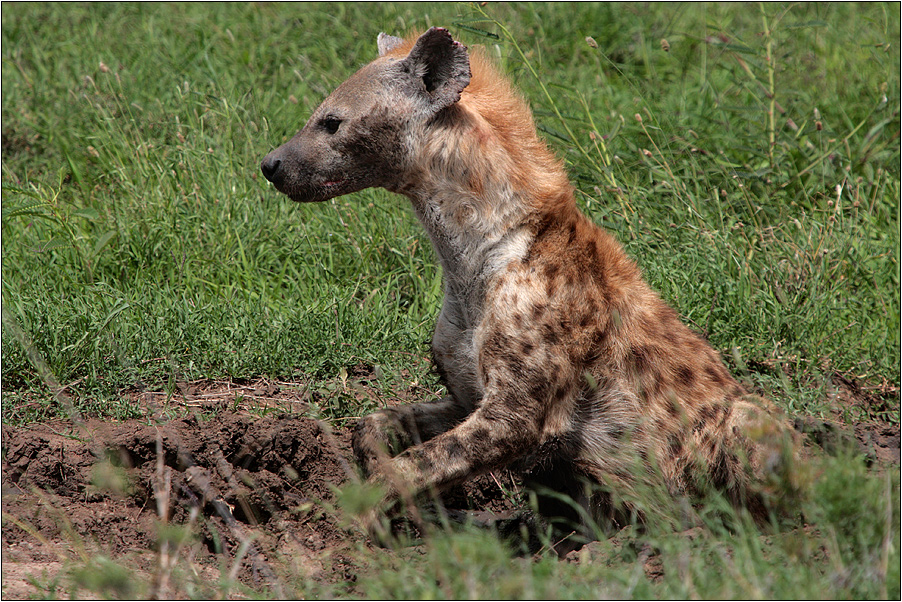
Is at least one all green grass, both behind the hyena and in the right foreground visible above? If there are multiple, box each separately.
[0,3,902,597]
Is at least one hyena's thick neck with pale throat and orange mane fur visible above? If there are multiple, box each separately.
[398,102,576,300]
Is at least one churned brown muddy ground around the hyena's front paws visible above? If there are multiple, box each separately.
[2,382,900,599]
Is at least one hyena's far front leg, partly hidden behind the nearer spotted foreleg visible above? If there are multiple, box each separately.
[351,395,471,476]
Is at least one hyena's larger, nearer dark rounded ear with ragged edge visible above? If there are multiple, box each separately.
[404,27,470,111]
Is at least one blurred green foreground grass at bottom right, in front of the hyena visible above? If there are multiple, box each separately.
[357,457,899,600]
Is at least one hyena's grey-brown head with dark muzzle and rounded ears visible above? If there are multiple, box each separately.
[260,27,470,202]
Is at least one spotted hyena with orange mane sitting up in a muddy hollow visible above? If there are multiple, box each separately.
[261,28,800,540]
